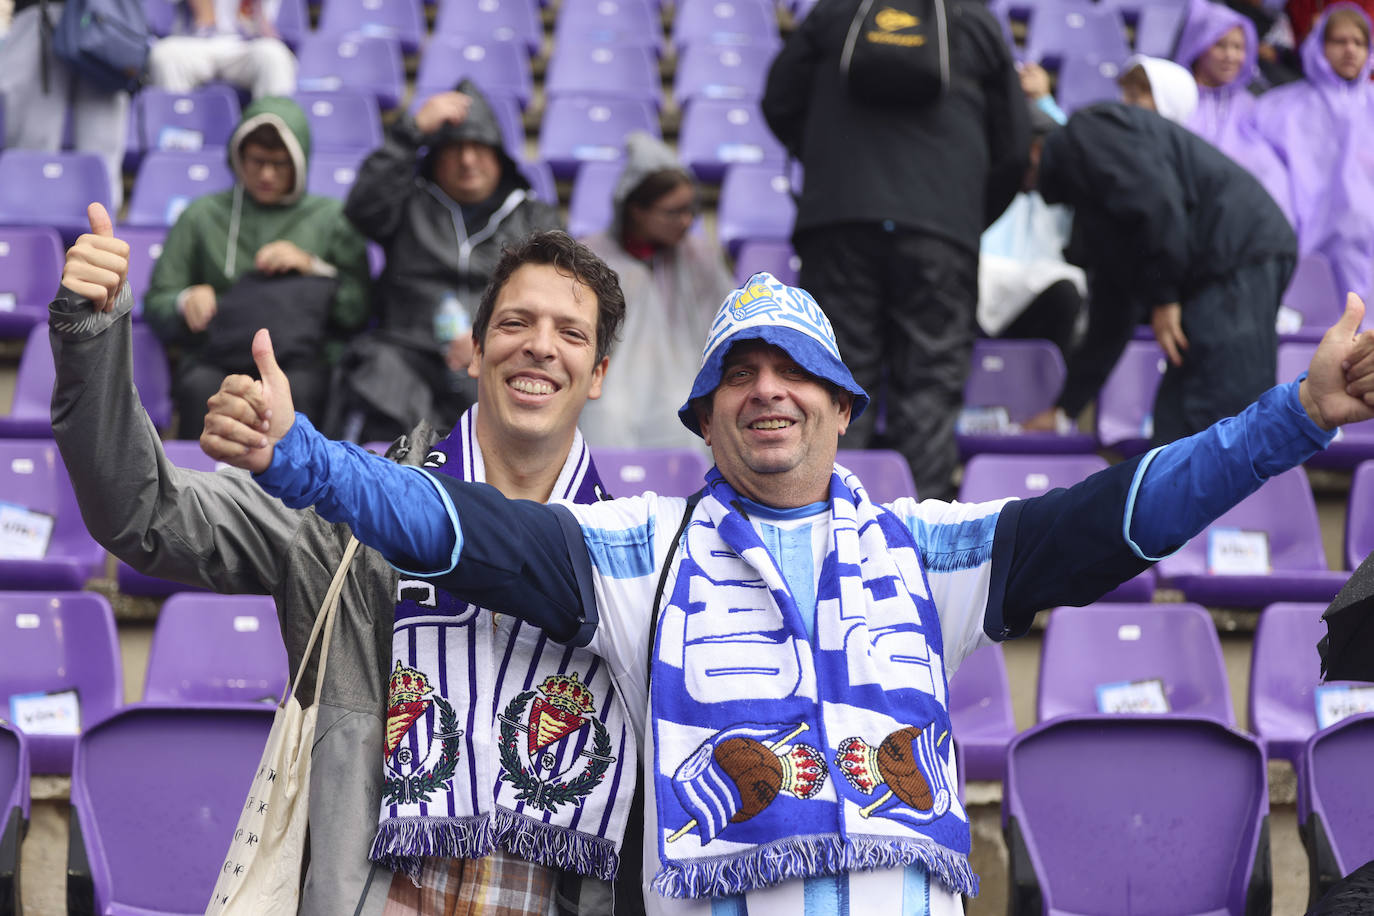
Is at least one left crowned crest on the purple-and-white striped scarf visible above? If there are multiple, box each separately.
[382,661,463,805]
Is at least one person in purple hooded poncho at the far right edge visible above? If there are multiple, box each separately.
[1254,3,1374,304]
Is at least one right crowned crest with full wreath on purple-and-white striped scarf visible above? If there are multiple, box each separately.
[499,672,616,812]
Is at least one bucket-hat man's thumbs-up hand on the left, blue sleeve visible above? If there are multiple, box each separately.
[201,328,295,474]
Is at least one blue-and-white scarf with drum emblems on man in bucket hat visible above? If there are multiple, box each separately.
[651,466,978,897]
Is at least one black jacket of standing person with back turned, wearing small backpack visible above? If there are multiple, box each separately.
[763,0,1031,254]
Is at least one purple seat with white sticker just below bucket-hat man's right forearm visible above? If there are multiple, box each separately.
[1156,468,1349,607]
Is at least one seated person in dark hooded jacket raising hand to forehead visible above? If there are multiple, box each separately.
[343,80,562,441]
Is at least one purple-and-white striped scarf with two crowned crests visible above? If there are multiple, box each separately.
[371,407,636,880]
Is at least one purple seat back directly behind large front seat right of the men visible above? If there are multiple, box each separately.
[1036,604,1235,726]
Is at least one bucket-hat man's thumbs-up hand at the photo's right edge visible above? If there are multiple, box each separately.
[1297,293,1374,430]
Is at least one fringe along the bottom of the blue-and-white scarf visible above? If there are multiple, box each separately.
[653,836,978,898]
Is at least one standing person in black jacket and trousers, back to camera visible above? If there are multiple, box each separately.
[763,0,1031,499]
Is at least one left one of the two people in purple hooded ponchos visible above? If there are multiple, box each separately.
[1173,0,1294,222]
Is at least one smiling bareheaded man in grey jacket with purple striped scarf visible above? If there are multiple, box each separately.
[51,222,636,916]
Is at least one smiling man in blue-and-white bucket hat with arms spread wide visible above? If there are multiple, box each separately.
[203,273,1374,916]
